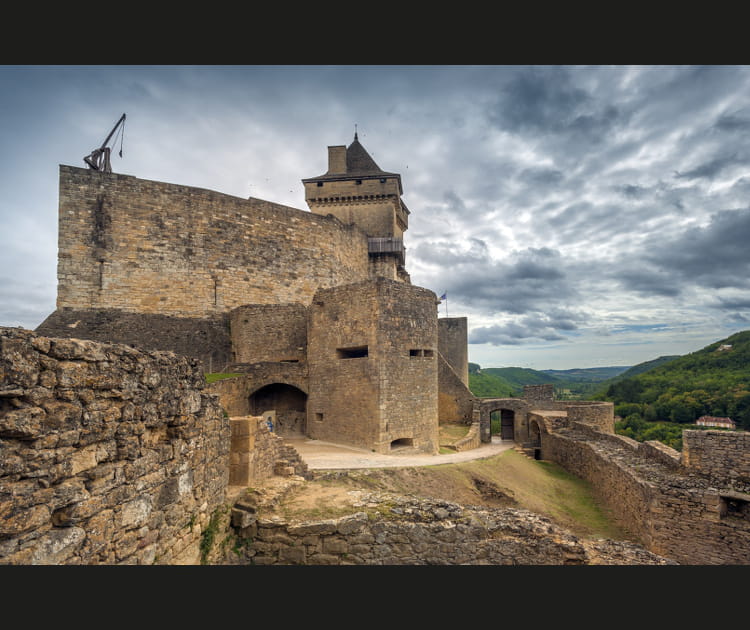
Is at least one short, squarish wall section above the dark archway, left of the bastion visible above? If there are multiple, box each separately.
[229,304,307,363]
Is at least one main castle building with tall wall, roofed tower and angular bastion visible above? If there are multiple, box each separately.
[36,134,472,453]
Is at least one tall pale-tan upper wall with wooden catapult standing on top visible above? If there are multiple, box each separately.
[57,165,369,318]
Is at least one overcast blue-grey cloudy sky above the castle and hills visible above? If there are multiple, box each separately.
[0,66,750,369]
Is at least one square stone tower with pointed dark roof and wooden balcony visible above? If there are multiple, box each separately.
[302,132,409,282]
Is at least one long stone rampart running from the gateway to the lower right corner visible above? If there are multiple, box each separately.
[542,423,750,564]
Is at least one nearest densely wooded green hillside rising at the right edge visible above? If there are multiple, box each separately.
[594,331,750,430]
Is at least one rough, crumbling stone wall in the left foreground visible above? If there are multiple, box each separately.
[0,328,230,564]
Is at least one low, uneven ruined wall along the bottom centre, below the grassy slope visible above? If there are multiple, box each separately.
[225,491,674,565]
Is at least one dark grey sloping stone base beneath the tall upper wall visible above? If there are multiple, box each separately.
[34,308,232,372]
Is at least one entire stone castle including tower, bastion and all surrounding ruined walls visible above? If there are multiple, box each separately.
[0,134,750,564]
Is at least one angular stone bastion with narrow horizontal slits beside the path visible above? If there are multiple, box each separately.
[307,278,438,453]
